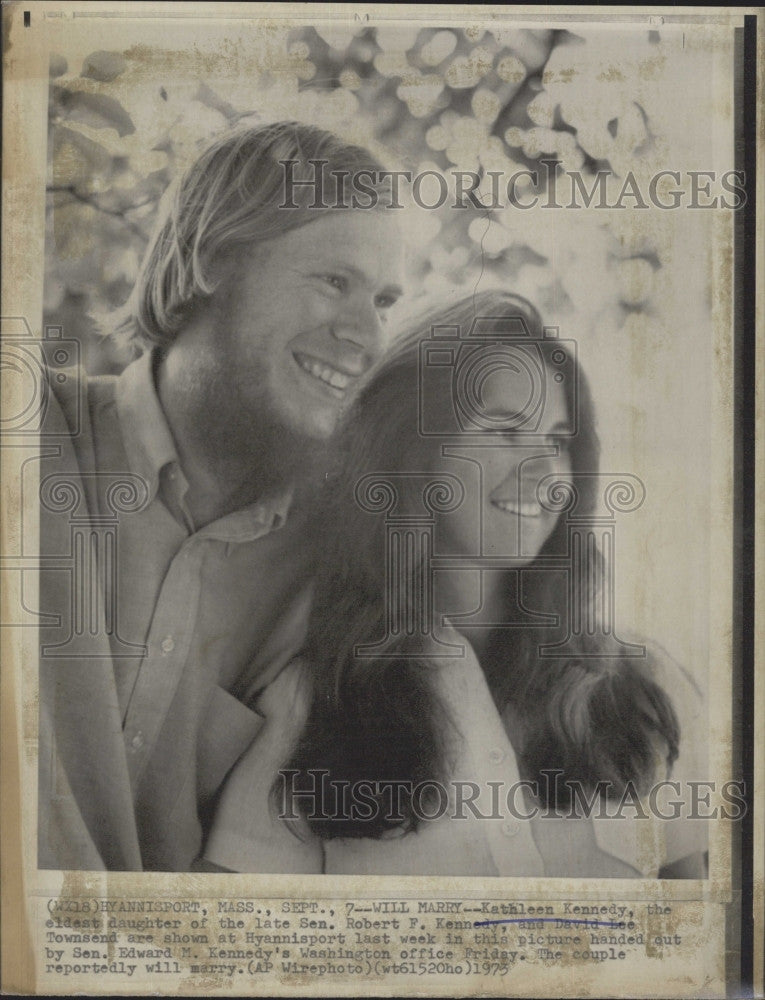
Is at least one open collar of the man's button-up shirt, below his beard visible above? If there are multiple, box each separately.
[115,349,292,542]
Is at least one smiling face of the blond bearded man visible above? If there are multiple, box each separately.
[203,209,402,439]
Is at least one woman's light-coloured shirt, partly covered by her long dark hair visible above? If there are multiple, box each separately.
[205,637,708,878]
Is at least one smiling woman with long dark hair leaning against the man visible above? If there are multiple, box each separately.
[201,292,704,876]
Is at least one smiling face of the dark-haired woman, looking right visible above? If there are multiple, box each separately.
[437,364,572,565]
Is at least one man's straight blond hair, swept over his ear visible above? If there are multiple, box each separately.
[111,122,384,348]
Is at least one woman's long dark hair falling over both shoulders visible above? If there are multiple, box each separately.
[273,292,679,838]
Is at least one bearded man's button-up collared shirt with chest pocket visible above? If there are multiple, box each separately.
[46,354,309,871]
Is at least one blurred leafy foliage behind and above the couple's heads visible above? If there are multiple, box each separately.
[44,22,698,372]
